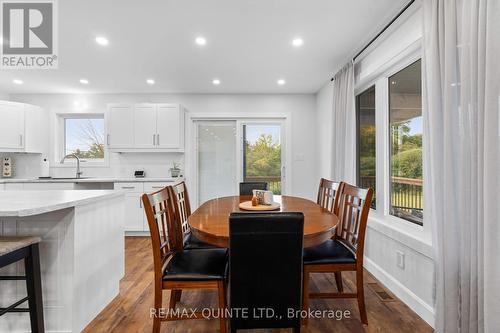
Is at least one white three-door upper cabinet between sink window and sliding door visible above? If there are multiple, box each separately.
[106,103,184,152]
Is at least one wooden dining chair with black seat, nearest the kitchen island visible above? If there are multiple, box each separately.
[142,187,227,333]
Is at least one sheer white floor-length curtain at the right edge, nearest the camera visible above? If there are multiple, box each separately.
[423,0,500,333]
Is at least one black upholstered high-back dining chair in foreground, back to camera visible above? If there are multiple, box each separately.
[229,213,304,333]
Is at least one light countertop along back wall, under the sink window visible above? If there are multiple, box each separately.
[0,177,184,184]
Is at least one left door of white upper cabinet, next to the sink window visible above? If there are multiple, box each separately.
[105,104,134,149]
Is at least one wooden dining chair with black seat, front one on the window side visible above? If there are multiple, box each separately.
[302,183,373,324]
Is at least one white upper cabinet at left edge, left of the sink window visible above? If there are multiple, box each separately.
[0,101,49,153]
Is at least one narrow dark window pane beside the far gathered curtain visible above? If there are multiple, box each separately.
[356,86,376,209]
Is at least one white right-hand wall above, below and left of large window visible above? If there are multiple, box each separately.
[316,2,434,325]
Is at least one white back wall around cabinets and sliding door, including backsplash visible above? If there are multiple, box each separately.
[10,94,317,198]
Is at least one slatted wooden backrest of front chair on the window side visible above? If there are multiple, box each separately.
[336,183,373,263]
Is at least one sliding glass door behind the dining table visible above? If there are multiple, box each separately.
[197,119,286,206]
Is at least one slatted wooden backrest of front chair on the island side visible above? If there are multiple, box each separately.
[142,187,176,281]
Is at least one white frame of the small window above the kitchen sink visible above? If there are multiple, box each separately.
[52,113,109,168]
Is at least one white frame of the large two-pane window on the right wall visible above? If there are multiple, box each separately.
[354,40,432,243]
